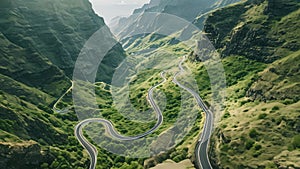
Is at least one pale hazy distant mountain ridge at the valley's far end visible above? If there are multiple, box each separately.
[111,0,240,43]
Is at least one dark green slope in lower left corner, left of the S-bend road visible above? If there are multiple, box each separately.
[0,88,88,168]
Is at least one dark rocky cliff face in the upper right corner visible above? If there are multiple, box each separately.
[204,0,299,63]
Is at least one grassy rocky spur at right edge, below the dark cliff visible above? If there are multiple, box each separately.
[249,51,300,104]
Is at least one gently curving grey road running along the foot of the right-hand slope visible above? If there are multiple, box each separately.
[173,57,213,169]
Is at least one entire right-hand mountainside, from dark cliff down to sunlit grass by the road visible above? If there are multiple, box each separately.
[191,0,300,168]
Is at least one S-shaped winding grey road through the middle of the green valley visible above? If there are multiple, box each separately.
[74,72,166,169]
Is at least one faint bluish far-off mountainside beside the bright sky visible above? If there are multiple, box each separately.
[111,0,240,43]
